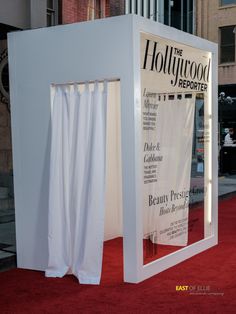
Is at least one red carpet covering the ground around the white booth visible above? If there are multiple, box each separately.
[0,197,236,314]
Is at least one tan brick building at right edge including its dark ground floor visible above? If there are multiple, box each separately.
[196,0,236,138]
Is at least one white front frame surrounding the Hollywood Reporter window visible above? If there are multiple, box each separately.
[131,16,218,282]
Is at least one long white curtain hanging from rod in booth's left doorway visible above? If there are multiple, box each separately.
[46,82,107,284]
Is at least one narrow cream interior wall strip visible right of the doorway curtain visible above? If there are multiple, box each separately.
[104,81,123,241]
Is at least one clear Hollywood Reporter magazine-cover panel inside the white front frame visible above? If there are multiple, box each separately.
[140,33,216,265]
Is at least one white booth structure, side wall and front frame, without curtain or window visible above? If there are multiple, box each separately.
[8,15,218,283]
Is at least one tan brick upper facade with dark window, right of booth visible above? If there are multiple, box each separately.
[196,0,236,97]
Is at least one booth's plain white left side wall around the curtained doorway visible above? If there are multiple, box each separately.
[9,16,136,274]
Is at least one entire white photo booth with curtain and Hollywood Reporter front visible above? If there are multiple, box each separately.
[8,15,218,284]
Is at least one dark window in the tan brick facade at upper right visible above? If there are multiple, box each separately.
[220,25,236,63]
